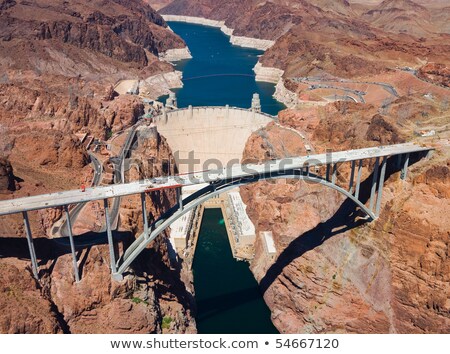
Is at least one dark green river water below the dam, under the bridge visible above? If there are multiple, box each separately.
[193,209,278,334]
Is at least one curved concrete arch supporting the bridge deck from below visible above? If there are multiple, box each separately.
[113,170,381,280]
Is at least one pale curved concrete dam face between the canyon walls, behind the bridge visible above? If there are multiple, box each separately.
[154,106,276,174]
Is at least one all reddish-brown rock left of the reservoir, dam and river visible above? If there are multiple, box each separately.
[0,0,195,333]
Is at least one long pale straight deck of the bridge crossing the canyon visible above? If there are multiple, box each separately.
[0,143,431,215]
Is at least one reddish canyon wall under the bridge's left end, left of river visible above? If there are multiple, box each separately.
[0,129,195,333]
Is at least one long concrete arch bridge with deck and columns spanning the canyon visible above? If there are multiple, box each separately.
[0,143,432,282]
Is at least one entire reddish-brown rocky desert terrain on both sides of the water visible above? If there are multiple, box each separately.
[0,0,450,333]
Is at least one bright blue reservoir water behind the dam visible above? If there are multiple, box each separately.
[165,22,285,115]
